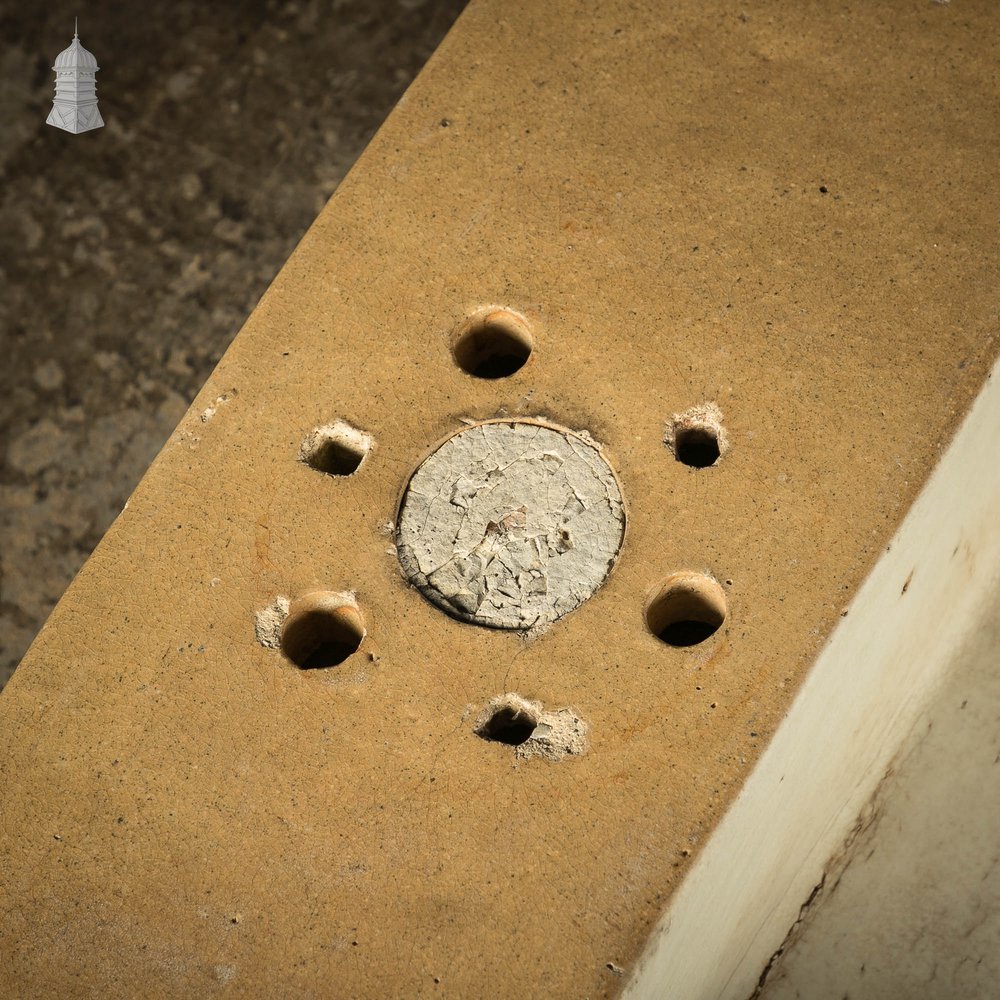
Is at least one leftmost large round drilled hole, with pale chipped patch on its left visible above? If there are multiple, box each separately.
[280,593,365,670]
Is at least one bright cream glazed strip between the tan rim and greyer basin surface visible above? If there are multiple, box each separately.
[624,362,1000,1000]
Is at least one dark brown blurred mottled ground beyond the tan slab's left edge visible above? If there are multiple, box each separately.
[0,0,465,686]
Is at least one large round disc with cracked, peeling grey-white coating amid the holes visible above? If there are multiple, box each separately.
[396,420,625,629]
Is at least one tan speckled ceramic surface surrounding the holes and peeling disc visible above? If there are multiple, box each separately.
[0,0,1000,998]
